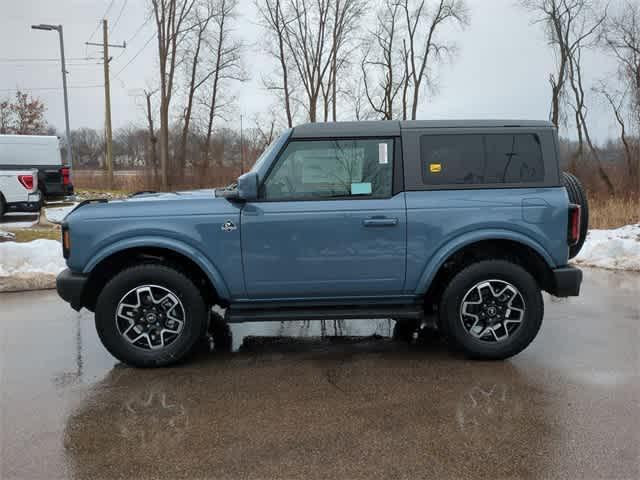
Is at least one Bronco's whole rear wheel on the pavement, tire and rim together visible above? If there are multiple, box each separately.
[439,260,544,360]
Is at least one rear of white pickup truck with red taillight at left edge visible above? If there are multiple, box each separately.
[0,169,42,218]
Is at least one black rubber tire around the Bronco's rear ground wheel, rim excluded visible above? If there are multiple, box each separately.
[439,260,544,360]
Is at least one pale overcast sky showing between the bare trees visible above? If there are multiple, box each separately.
[0,0,617,141]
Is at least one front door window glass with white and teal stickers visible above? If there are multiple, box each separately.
[261,139,393,200]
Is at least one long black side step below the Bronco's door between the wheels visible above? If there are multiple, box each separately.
[225,304,424,323]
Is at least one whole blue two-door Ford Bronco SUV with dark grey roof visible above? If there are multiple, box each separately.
[57,121,588,367]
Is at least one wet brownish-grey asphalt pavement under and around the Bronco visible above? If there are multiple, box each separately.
[0,270,640,479]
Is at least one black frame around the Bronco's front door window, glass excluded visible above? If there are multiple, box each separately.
[252,135,404,203]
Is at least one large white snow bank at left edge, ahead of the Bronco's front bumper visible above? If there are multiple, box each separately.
[0,239,66,277]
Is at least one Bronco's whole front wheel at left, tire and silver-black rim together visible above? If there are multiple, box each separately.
[95,264,209,367]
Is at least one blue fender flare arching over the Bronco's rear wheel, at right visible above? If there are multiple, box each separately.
[415,229,556,295]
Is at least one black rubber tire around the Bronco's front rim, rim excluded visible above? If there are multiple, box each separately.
[95,264,209,368]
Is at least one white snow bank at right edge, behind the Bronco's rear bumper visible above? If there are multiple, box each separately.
[573,224,640,271]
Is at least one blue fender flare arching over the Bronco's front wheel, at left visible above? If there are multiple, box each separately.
[83,236,230,300]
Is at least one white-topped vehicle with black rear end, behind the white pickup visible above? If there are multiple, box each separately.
[0,135,73,200]
